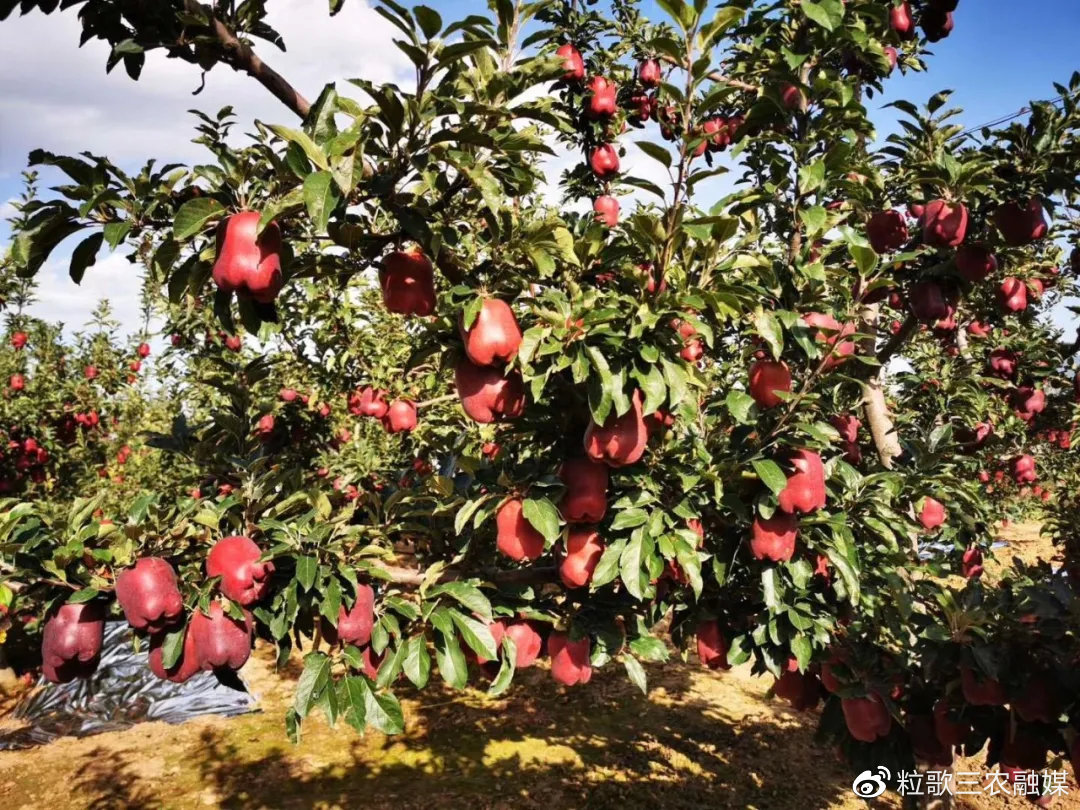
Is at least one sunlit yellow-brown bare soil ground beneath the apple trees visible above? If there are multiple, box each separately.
[0,528,1080,810]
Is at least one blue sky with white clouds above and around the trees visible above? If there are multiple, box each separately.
[0,0,1080,323]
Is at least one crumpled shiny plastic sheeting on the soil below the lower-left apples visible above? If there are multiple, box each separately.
[0,622,256,751]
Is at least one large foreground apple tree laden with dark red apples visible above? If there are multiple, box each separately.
[5,0,1080,794]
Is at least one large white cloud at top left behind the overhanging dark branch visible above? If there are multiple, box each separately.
[0,0,413,171]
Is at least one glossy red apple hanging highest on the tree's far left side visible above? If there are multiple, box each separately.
[213,211,283,303]
